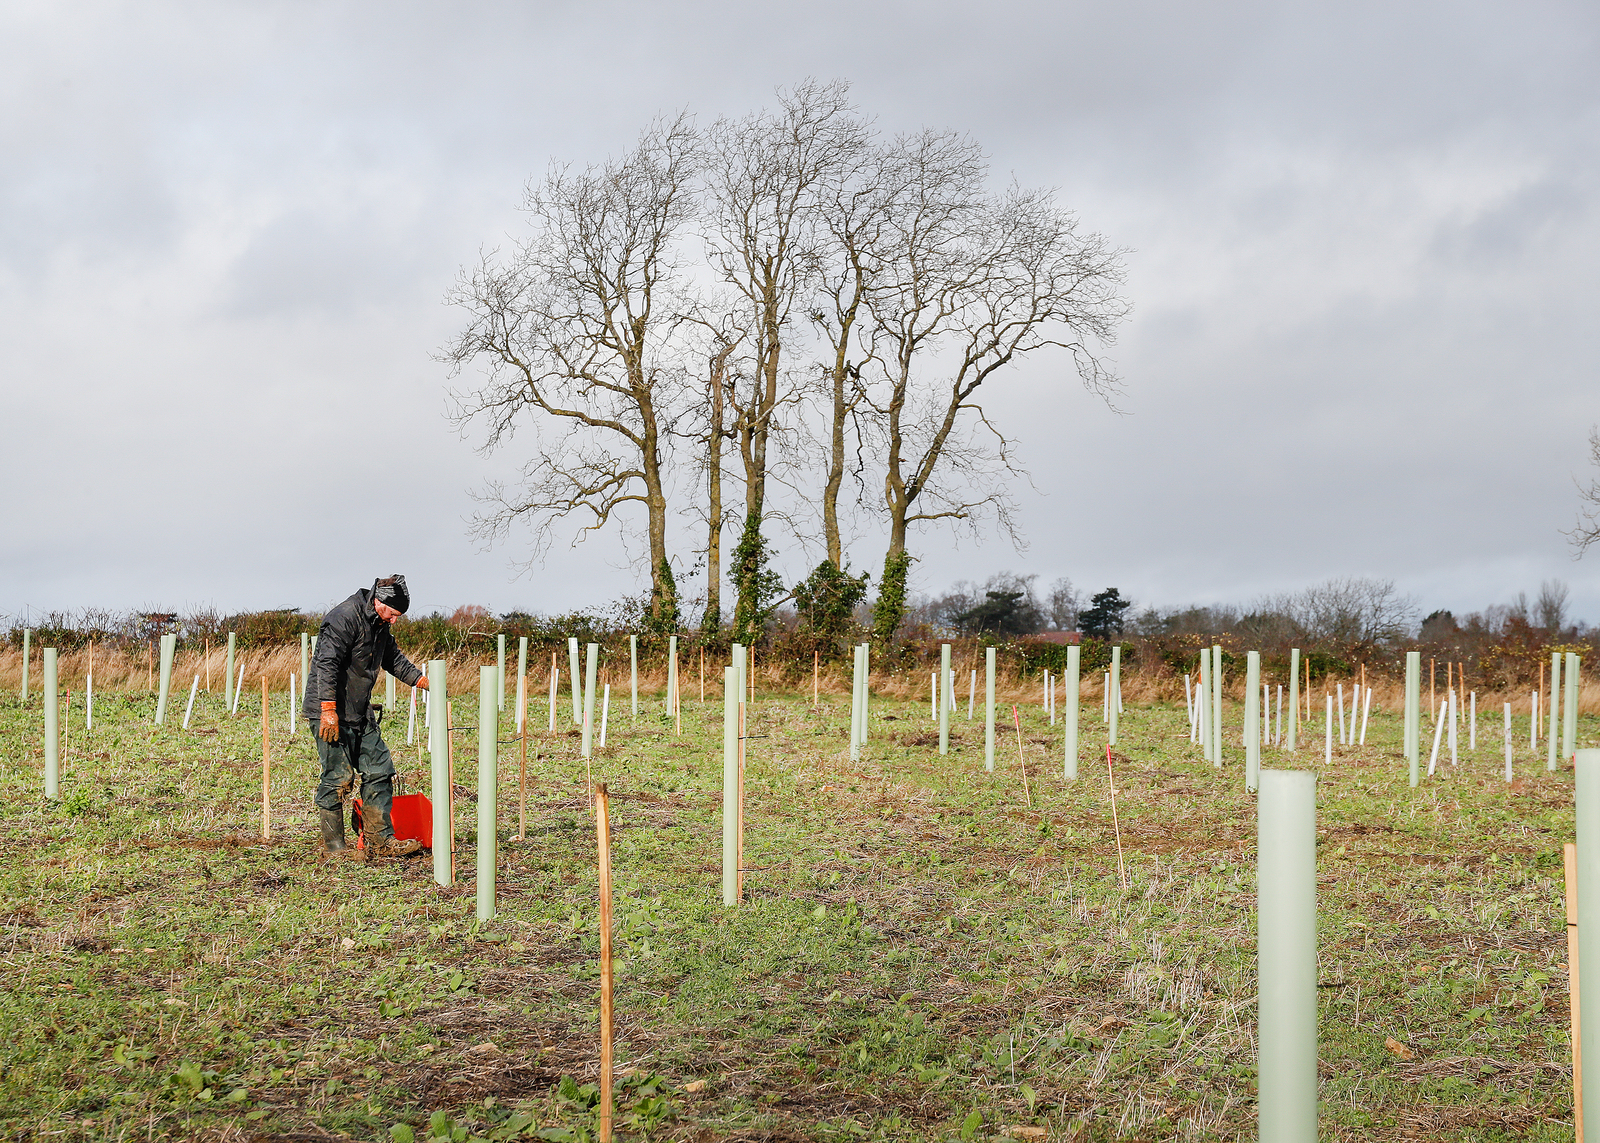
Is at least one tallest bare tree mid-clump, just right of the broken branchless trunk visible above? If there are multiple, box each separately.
[706,80,867,639]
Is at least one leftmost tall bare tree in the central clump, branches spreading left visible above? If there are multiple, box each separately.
[442,115,699,629]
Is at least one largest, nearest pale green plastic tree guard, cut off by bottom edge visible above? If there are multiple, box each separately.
[1256,770,1317,1143]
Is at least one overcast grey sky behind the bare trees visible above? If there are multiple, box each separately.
[0,0,1600,623]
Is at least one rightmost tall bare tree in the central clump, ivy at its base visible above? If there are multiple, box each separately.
[870,131,1128,639]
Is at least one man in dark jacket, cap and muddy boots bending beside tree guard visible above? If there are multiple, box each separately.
[301,575,427,856]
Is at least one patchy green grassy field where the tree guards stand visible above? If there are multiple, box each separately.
[0,681,1600,1141]
